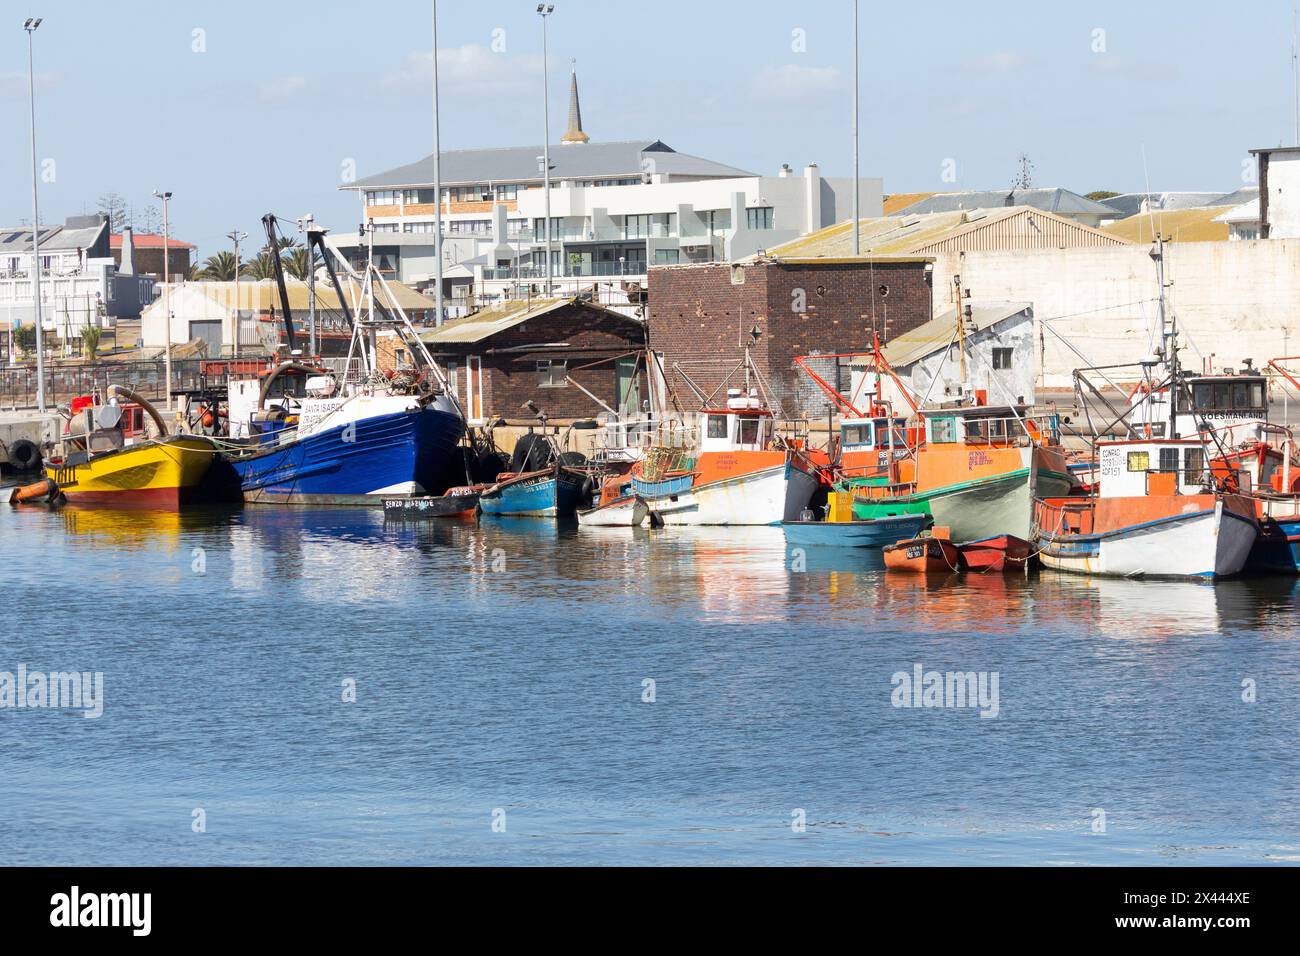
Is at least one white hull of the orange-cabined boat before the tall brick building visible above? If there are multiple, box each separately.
[634,460,818,525]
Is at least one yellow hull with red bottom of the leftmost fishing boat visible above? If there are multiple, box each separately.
[46,434,217,509]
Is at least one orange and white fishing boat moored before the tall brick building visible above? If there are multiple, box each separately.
[631,389,818,525]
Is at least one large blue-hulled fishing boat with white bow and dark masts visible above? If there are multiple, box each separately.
[226,215,465,505]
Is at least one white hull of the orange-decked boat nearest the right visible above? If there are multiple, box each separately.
[1036,498,1258,579]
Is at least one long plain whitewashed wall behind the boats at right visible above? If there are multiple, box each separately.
[933,239,1300,388]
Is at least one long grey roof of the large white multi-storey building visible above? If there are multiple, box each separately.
[342,139,754,189]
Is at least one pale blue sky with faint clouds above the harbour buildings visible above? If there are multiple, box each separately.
[0,0,1294,255]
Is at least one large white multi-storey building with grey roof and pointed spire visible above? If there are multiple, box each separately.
[333,68,883,315]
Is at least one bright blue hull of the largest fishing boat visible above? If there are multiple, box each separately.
[228,406,464,505]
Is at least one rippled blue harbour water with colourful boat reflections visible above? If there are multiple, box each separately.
[0,481,1300,865]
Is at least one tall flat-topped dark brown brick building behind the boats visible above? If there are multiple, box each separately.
[649,256,932,419]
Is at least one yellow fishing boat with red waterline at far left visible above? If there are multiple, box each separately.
[46,385,217,509]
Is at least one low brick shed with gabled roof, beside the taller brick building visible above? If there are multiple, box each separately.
[413,299,649,424]
